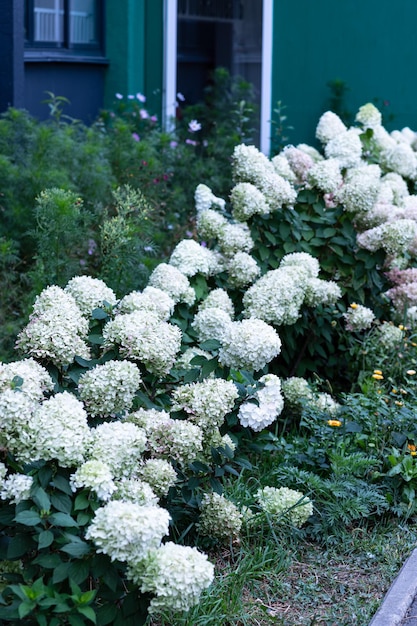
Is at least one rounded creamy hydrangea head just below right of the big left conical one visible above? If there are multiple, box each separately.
[78,361,142,417]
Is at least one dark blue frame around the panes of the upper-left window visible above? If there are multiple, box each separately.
[24,0,105,59]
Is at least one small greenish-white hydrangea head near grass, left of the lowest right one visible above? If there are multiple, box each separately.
[197,492,242,541]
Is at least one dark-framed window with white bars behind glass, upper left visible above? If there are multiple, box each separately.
[25,0,101,52]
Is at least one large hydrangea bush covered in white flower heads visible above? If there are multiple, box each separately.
[4,105,417,626]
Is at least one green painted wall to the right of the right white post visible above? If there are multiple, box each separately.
[272,0,417,143]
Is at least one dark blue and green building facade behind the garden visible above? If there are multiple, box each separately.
[0,0,417,152]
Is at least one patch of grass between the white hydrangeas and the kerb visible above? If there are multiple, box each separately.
[149,521,417,626]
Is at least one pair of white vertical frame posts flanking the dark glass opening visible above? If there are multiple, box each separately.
[162,0,273,155]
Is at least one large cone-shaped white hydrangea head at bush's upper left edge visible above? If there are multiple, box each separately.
[16,286,90,366]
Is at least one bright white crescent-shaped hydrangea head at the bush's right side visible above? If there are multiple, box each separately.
[238,374,284,432]
